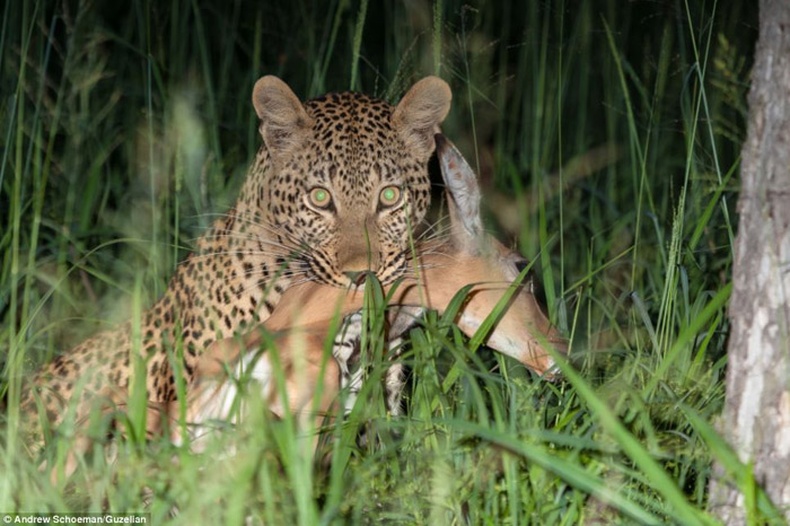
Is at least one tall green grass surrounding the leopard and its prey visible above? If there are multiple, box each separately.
[0,0,771,524]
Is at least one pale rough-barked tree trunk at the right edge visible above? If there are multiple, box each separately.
[709,0,790,525]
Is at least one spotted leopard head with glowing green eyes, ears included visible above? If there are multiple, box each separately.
[253,76,451,287]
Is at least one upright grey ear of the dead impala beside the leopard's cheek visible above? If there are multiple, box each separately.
[435,134,483,254]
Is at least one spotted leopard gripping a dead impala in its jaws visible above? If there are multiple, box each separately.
[21,75,452,469]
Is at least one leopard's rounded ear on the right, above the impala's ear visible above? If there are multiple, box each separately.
[392,77,453,161]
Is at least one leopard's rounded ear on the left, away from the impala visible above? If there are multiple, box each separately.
[252,75,313,159]
